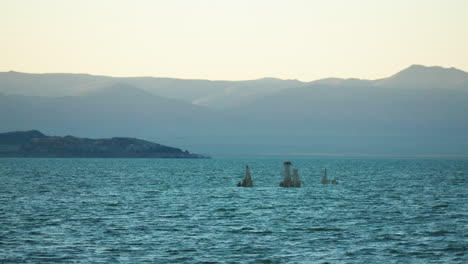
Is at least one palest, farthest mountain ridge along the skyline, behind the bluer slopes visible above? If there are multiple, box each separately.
[0,65,468,109]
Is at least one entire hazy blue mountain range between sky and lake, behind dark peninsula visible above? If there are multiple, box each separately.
[0,65,468,156]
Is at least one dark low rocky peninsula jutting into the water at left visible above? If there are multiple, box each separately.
[0,130,208,159]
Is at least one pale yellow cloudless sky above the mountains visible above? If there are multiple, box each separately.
[0,0,468,81]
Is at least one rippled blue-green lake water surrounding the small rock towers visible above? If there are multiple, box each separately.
[0,159,468,263]
